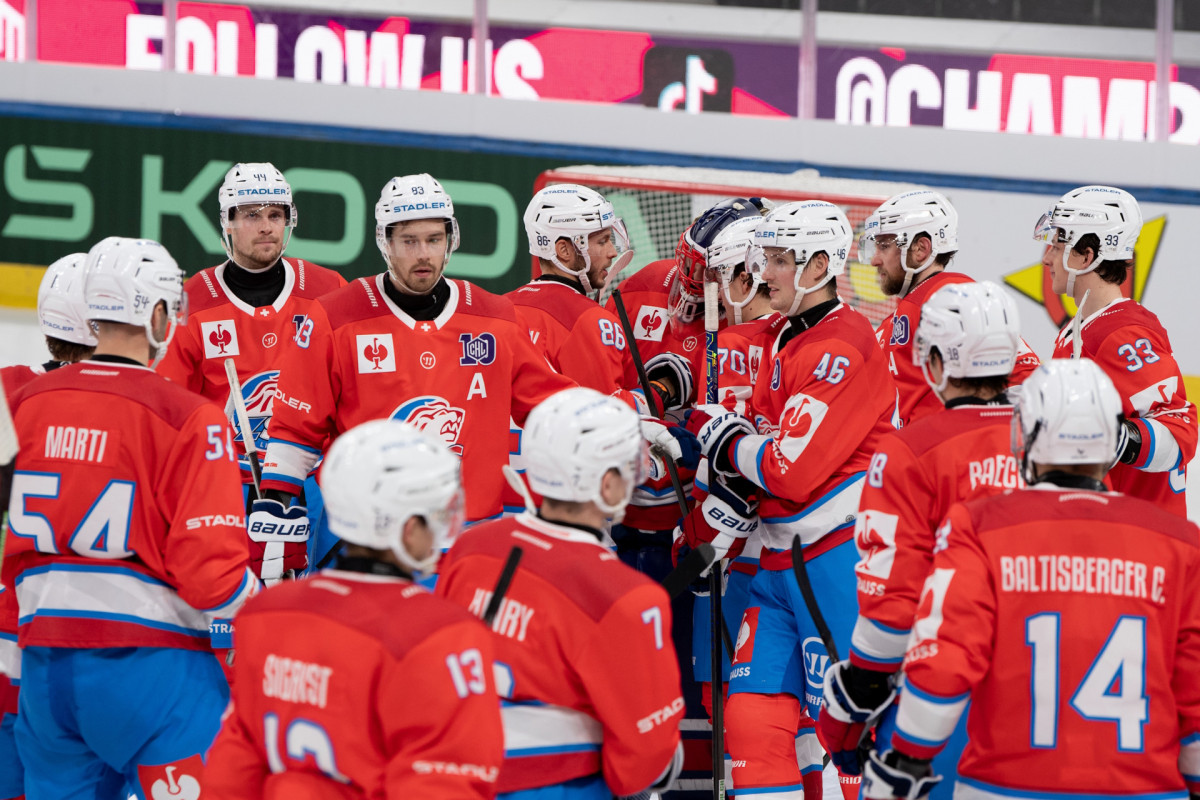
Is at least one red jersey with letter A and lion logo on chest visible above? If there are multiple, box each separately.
[263,273,575,521]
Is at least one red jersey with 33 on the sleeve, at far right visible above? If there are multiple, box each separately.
[1054,299,1196,517]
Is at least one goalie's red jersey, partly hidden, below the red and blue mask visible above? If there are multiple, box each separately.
[605,259,706,530]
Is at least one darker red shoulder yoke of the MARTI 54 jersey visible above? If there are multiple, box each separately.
[18,361,224,429]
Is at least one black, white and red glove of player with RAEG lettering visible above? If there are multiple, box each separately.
[817,661,896,775]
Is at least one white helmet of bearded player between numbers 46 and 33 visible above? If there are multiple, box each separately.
[858,190,959,297]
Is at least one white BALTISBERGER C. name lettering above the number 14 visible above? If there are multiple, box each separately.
[1000,554,1166,606]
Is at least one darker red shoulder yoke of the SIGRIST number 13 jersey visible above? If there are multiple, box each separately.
[238,571,484,660]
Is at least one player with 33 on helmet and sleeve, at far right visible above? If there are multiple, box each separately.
[1034,186,1196,517]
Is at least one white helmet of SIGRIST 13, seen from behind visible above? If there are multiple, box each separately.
[320,420,463,573]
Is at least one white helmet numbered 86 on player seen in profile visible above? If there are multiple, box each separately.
[524,184,634,294]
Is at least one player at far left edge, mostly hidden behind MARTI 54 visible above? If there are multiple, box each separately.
[0,253,96,800]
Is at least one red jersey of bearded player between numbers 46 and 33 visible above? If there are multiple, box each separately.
[875,272,1040,425]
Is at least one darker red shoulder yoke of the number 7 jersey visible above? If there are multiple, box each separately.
[455,519,659,619]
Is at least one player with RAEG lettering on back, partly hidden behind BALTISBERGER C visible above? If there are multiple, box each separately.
[817,281,1024,798]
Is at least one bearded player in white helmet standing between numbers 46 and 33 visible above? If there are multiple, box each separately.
[858,190,1038,425]
